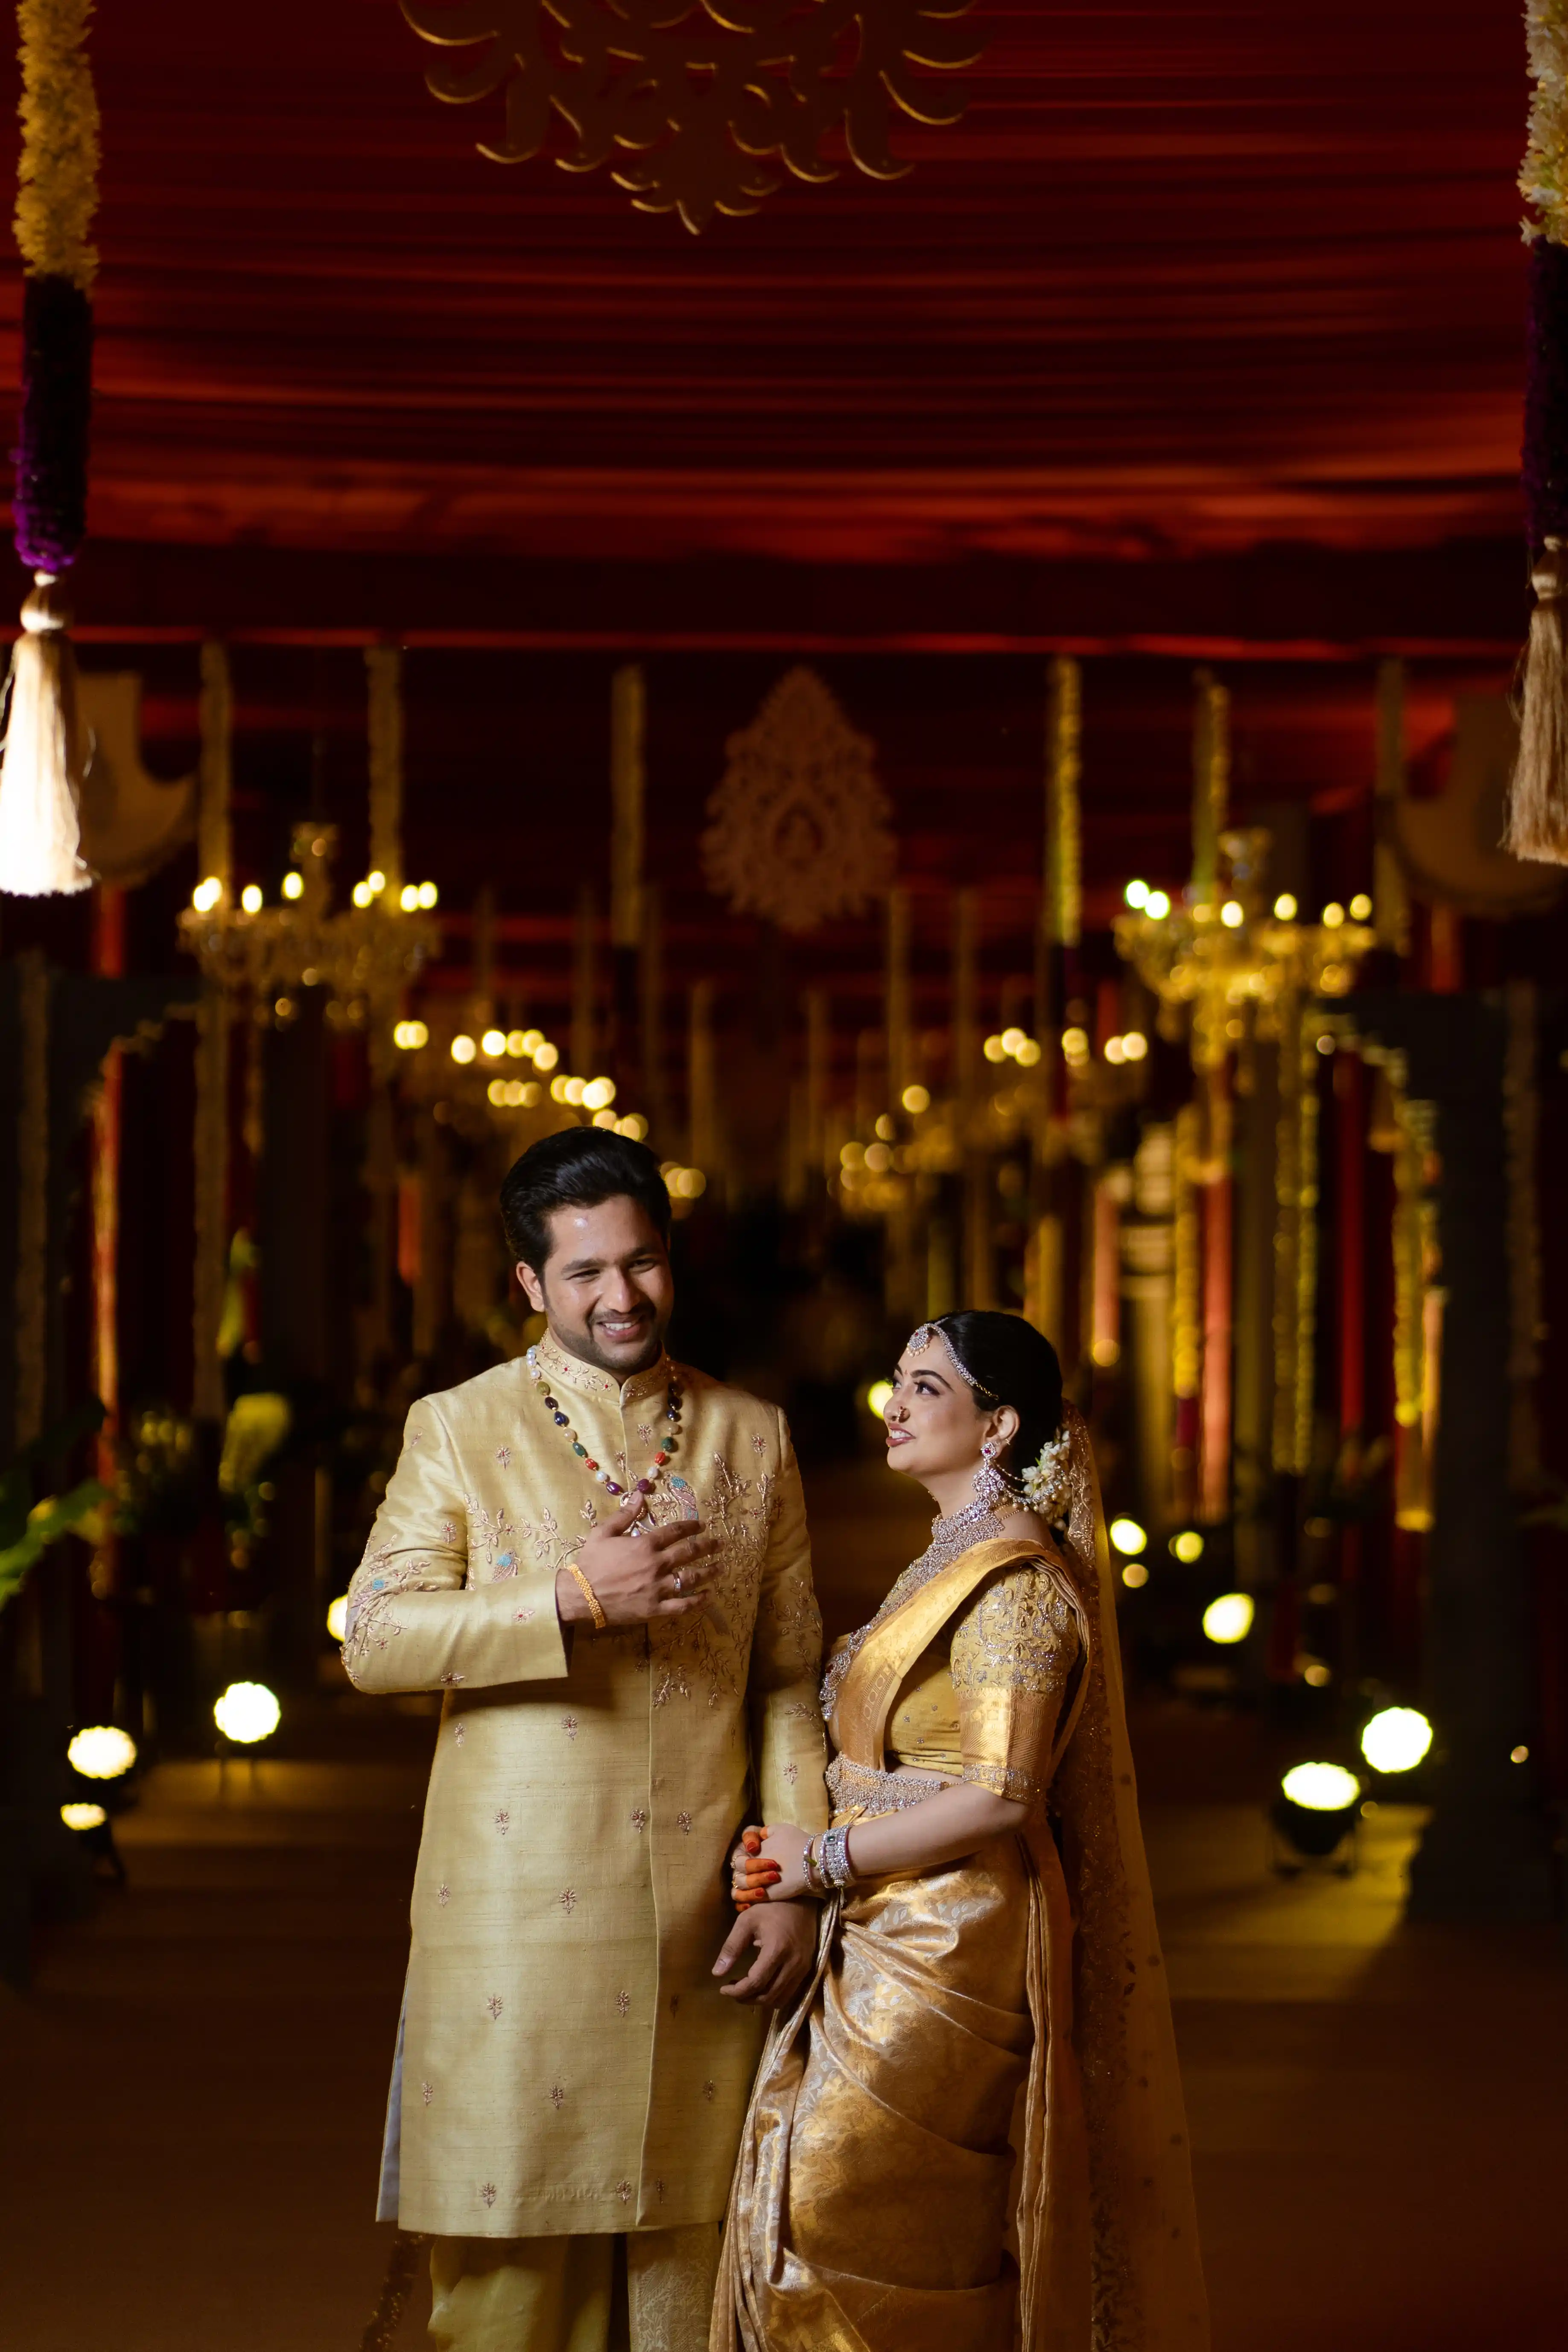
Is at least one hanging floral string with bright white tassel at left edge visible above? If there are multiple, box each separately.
[0,0,99,896]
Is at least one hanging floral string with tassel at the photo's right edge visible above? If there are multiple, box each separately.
[1504,0,1568,866]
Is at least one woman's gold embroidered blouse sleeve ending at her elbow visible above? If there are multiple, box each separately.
[950,1564,1079,1804]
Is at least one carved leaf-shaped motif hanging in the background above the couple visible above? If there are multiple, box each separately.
[703,668,893,931]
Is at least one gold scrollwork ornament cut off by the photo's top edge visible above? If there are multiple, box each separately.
[402,0,980,231]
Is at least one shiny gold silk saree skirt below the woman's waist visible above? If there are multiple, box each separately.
[722,1837,1034,2352]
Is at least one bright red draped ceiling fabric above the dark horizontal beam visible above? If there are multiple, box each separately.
[0,0,1523,562]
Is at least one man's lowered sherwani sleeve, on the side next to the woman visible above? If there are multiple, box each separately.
[750,1414,832,1830]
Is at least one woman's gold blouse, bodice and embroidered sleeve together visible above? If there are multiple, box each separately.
[886,1564,1079,1804]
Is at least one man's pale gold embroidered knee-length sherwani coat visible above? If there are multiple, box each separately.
[343,1338,827,2237]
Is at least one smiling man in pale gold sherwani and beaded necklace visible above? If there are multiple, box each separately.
[343,1129,827,2352]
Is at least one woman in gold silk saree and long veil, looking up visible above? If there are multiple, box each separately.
[712,1313,1208,2352]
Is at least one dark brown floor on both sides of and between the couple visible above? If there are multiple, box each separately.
[0,1482,1568,2352]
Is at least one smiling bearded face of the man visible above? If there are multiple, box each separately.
[517,1193,675,1380]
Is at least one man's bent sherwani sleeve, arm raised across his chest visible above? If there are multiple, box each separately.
[343,1397,569,1691]
